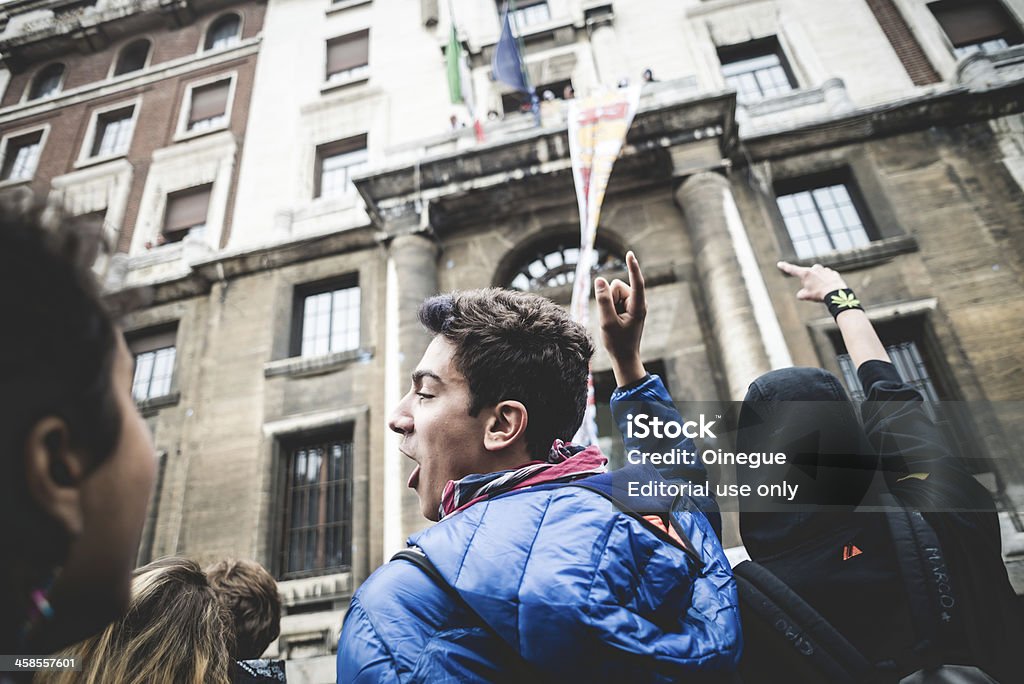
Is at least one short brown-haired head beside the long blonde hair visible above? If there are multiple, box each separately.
[206,559,281,660]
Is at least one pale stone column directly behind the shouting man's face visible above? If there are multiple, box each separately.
[384,232,438,560]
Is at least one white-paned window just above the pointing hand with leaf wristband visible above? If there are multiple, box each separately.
[775,174,876,259]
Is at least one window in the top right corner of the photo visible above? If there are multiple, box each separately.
[928,0,1024,57]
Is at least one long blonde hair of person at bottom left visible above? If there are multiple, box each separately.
[33,558,234,684]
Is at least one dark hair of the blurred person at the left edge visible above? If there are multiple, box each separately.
[0,197,121,554]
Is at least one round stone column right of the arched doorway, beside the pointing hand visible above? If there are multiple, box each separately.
[676,171,771,400]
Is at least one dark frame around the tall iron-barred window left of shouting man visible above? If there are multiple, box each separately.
[271,418,361,582]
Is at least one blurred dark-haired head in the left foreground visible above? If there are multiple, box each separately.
[0,197,156,652]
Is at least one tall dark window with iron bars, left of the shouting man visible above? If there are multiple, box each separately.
[281,429,353,579]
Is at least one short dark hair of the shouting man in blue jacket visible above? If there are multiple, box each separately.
[420,288,594,459]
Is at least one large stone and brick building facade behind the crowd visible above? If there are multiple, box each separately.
[0,0,1024,681]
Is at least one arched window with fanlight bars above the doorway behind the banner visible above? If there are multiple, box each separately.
[506,234,626,292]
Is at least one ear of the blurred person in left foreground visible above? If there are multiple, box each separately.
[25,416,86,538]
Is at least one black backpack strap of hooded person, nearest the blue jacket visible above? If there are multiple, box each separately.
[733,560,878,684]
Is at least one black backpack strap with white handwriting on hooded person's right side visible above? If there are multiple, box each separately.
[882,495,956,669]
